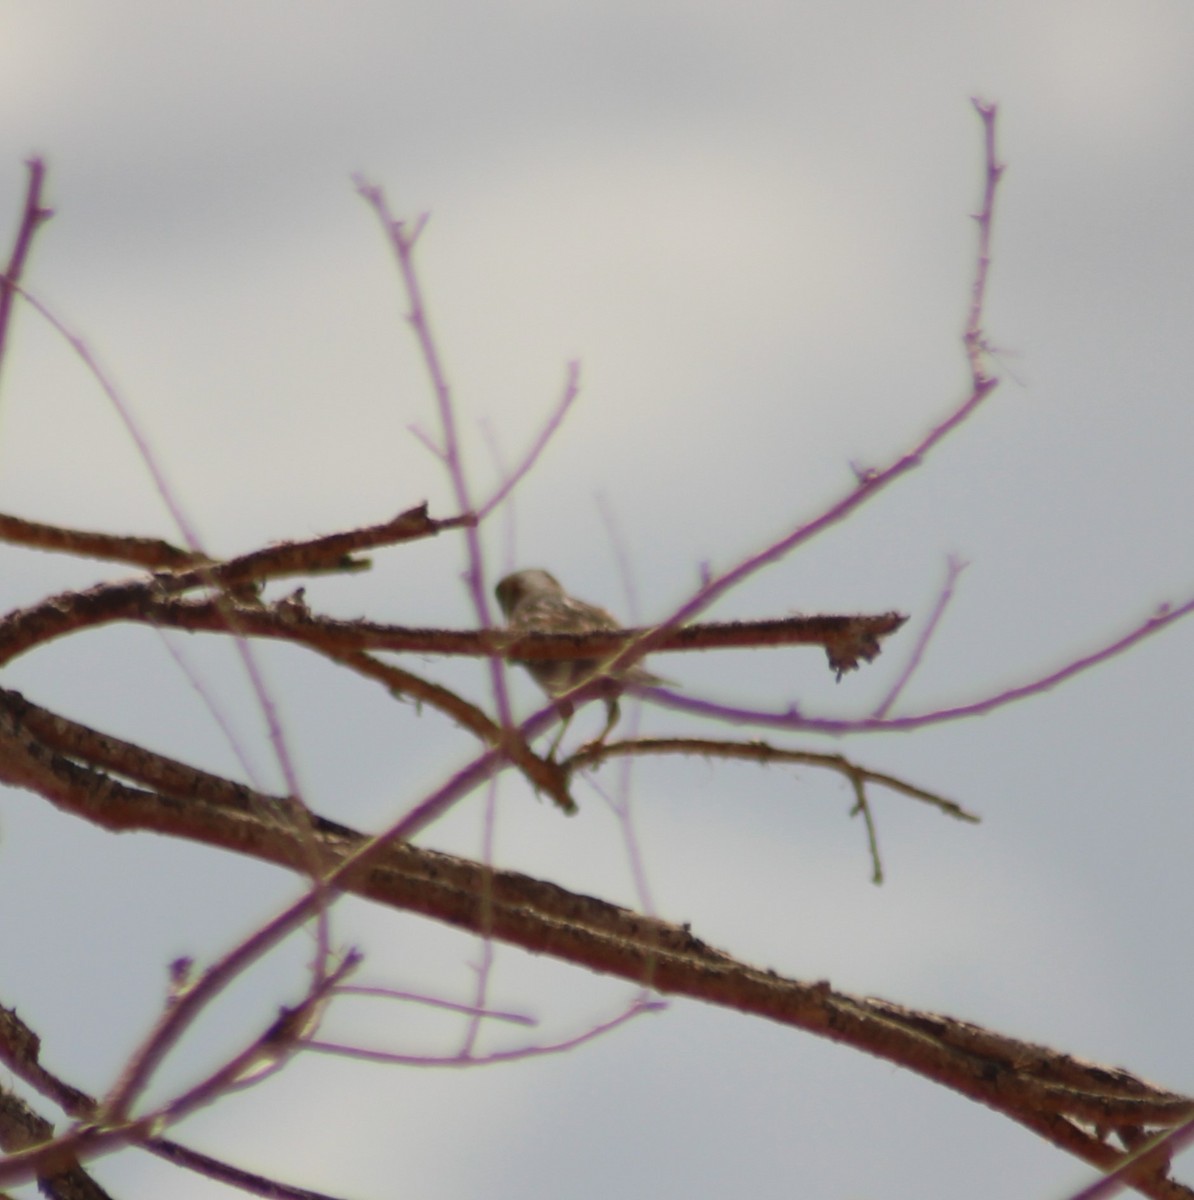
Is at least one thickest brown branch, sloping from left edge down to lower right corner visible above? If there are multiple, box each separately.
[0,712,1194,1196]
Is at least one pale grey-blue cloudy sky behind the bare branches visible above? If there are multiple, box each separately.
[0,0,1194,1200]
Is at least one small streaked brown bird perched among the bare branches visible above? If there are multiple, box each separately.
[493,568,667,757]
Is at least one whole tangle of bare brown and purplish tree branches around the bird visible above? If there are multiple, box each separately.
[0,101,1194,1200]
